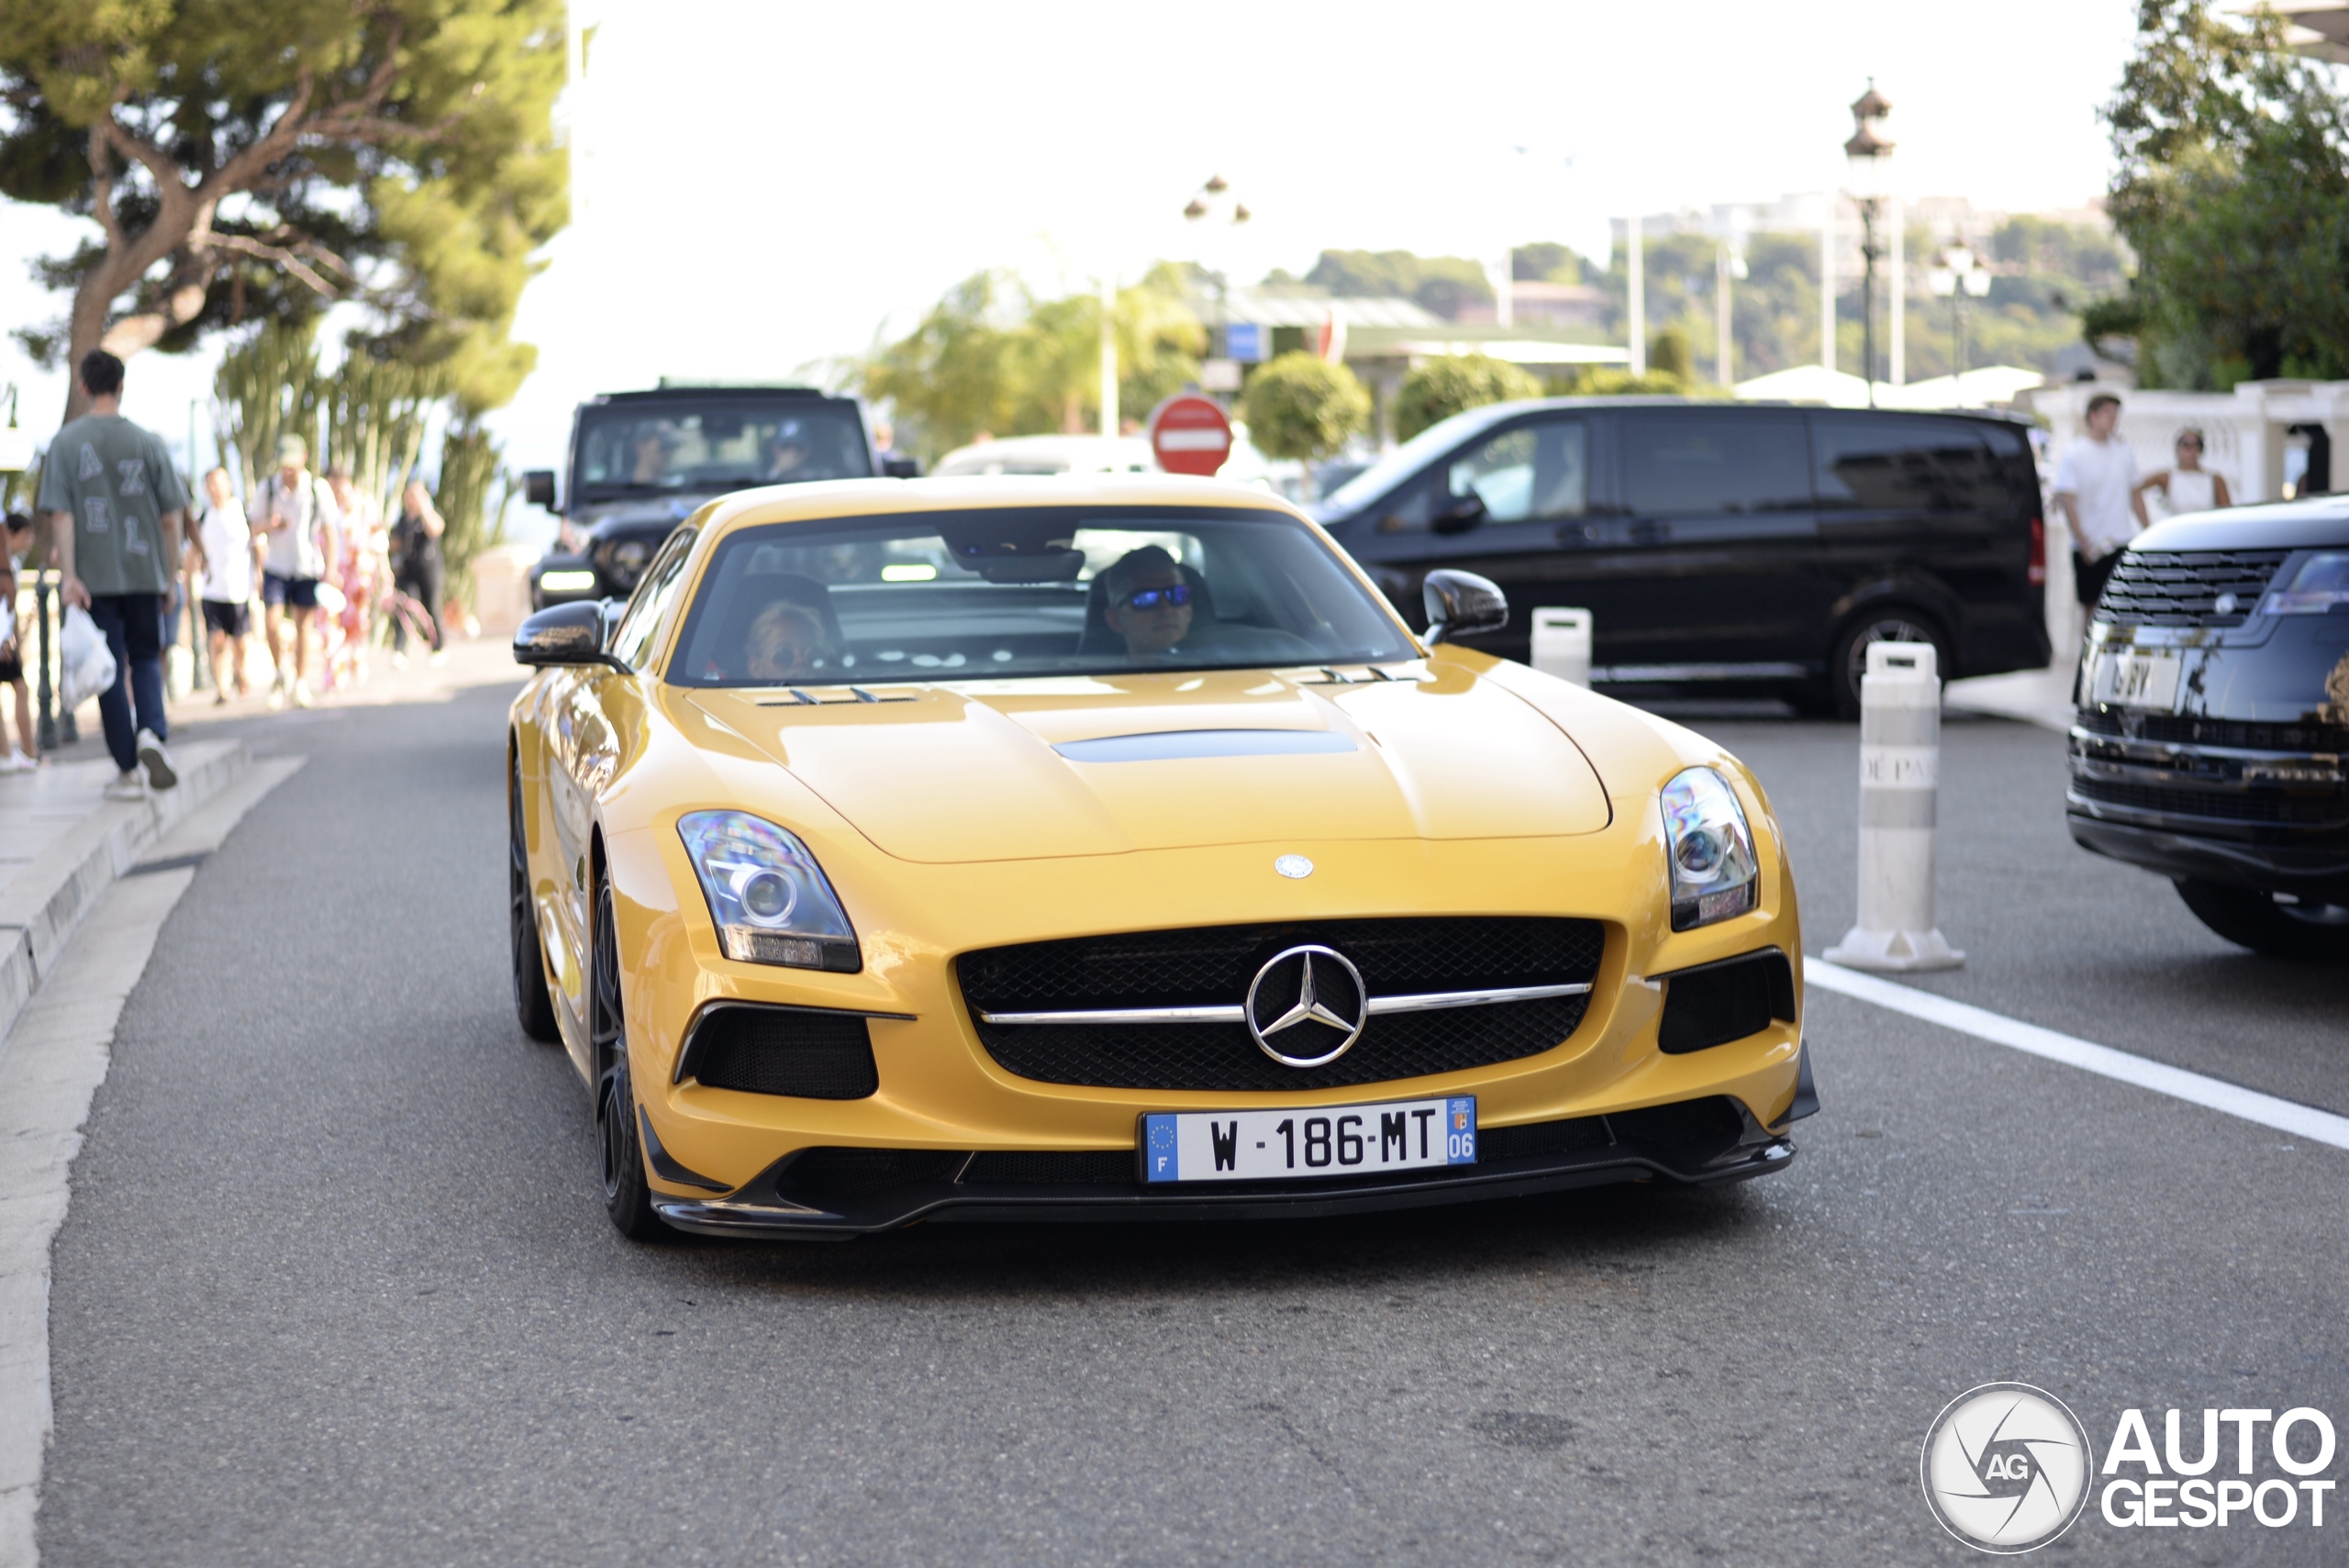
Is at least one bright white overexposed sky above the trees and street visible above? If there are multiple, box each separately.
[0,0,2135,523]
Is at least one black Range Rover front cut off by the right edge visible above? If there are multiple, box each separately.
[2067,509,2349,962]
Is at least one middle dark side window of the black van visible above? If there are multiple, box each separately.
[1620,408,1811,517]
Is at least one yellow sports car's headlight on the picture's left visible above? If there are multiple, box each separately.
[676,812,864,974]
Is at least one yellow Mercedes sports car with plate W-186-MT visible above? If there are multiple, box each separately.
[507,476,1816,1237]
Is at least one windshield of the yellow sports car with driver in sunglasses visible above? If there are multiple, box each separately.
[670,507,1419,685]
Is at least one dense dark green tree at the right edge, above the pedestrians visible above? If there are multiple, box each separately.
[2084,0,2349,390]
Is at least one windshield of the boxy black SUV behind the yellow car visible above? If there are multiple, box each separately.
[578,396,874,497]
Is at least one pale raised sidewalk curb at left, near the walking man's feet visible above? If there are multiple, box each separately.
[0,740,253,1051]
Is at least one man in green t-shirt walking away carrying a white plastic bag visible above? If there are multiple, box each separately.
[38,348,202,800]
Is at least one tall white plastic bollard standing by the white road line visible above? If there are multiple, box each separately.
[1825,643,1966,972]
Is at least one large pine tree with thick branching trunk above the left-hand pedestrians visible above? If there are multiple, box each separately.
[0,0,569,416]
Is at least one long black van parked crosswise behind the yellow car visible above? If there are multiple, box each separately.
[1320,396,2048,716]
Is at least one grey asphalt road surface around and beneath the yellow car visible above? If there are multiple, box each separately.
[40,690,2349,1565]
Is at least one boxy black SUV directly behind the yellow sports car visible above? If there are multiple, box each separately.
[524,385,914,610]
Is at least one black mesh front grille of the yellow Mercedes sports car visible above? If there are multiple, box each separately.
[956,916,1604,1092]
